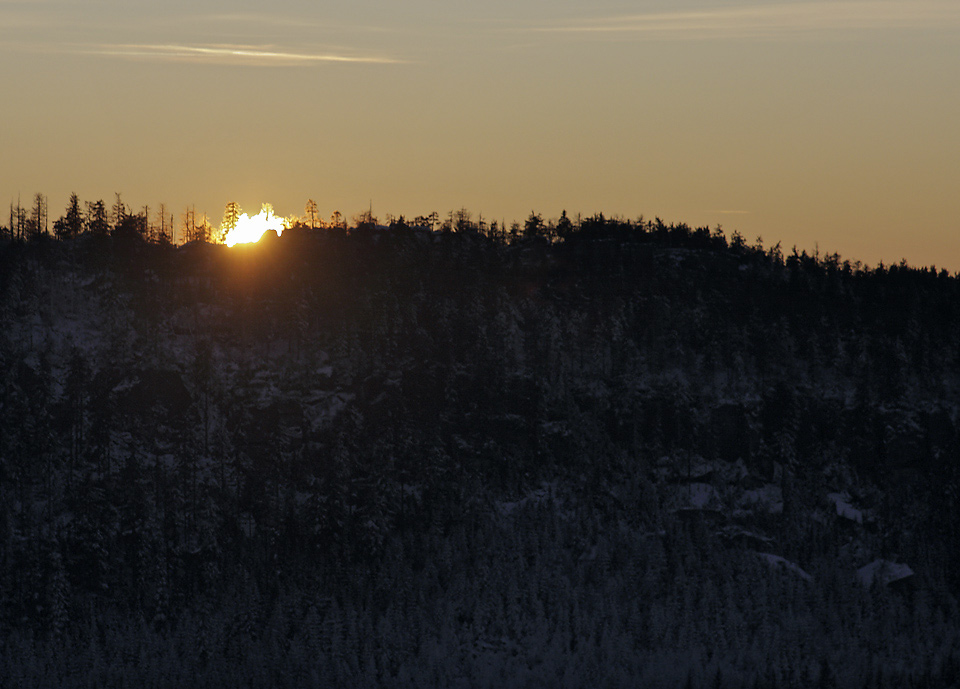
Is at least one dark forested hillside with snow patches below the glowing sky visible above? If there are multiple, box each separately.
[0,222,960,688]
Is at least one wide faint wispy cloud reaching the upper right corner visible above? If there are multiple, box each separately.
[535,0,960,40]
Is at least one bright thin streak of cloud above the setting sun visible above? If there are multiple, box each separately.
[80,44,404,67]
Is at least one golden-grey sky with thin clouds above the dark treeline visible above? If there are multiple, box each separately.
[0,0,960,271]
